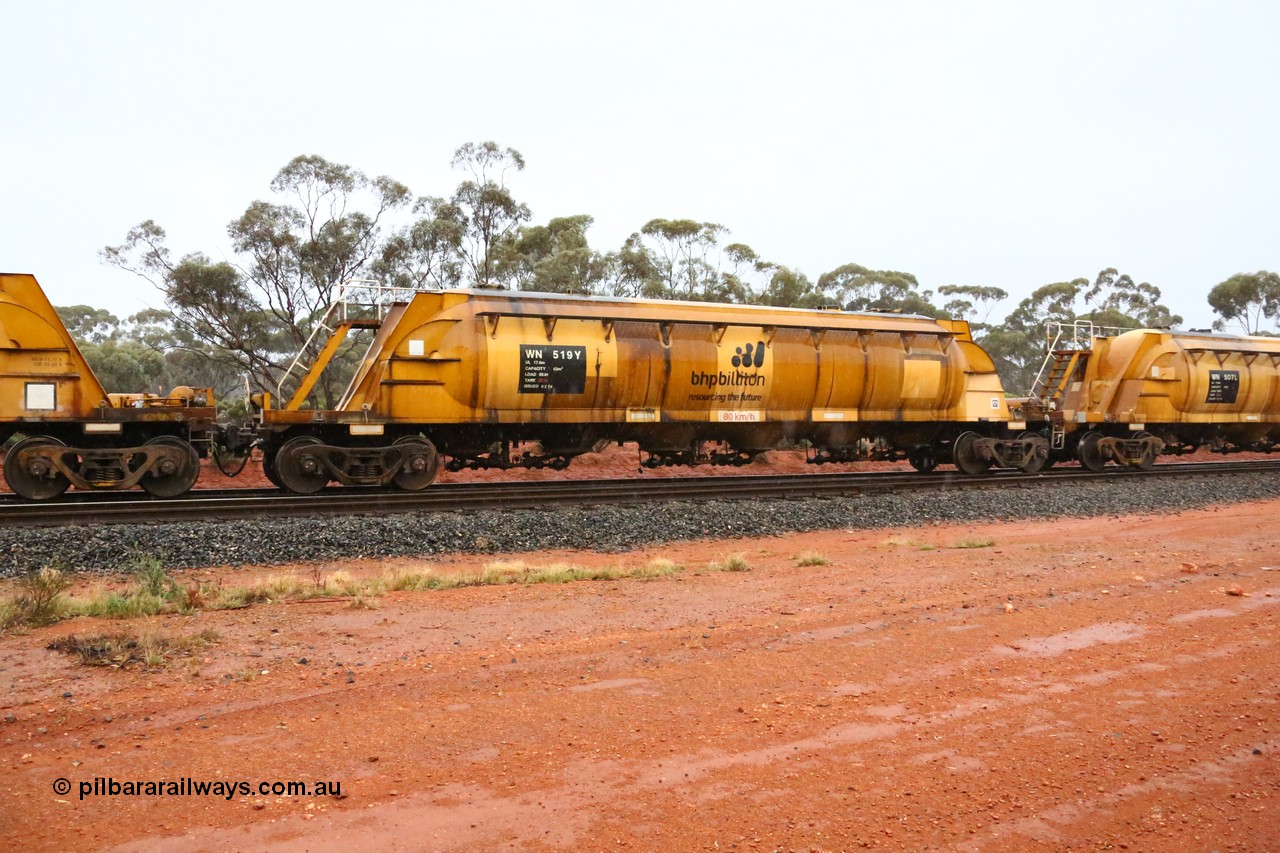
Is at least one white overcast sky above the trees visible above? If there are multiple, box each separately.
[0,0,1280,325]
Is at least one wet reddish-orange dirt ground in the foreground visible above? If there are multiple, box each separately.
[0,501,1280,850]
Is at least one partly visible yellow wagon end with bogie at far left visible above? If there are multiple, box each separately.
[0,273,215,500]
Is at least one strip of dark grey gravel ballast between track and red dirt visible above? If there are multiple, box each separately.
[0,473,1280,576]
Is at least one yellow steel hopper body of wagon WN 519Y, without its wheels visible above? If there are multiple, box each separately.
[288,291,1009,424]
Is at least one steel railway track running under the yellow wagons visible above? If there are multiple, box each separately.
[0,461,1280,528]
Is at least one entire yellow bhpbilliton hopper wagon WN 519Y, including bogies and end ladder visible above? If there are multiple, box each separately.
[262,291,1047,492]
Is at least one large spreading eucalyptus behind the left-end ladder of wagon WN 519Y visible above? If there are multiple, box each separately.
[101,156,411,405]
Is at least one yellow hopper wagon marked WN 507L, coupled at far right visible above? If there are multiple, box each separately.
[1053,329,1280,470]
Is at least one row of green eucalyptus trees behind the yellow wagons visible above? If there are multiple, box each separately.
[87,141,1259,406]
